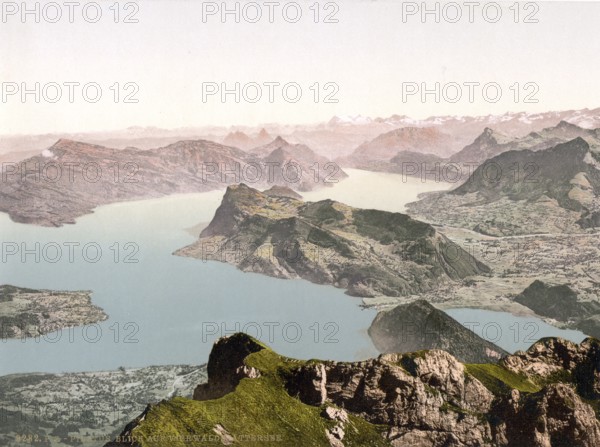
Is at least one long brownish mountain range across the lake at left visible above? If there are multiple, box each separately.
[0,139,346,226]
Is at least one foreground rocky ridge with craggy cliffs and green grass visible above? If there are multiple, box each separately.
[108,334,600,447]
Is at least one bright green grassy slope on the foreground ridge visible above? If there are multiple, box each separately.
[124,349,390,447]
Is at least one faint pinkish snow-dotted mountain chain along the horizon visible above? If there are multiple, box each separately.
[0,108,600,159]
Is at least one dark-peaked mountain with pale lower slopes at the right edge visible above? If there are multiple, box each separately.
[407,137,600,236]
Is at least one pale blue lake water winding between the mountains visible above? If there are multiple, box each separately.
[0,170,577,375]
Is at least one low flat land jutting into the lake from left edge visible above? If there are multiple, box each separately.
[0,285,108,339]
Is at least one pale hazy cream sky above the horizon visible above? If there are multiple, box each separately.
[0,0,600,134]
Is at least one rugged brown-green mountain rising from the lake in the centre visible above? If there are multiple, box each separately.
[176,184,489,297]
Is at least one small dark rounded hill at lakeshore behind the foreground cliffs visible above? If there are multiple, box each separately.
[369,300,508,363]
